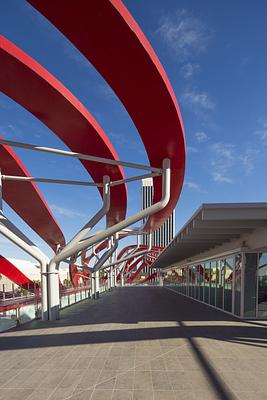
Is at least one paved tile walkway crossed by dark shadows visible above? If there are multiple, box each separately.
[0,287,267,400]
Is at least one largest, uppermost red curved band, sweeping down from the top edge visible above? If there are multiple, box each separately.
[28,0,185,230]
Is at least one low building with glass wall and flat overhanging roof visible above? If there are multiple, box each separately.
[153,203,267,319]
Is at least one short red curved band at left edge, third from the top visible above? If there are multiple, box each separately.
[0,145,65,251]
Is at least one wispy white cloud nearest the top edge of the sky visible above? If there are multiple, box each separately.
[157,10,211,62]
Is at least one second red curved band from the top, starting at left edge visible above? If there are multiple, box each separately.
[0,36,127,226]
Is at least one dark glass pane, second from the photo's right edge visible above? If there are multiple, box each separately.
[244,253,258,317]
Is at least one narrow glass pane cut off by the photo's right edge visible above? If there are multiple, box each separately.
[258,253,267,318]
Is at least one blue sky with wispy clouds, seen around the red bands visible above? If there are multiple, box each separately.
[0,0,267,259]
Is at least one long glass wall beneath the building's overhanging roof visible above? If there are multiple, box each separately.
[165,252,267,319]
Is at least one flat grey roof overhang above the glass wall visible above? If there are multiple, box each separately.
[152,203,267,268]
